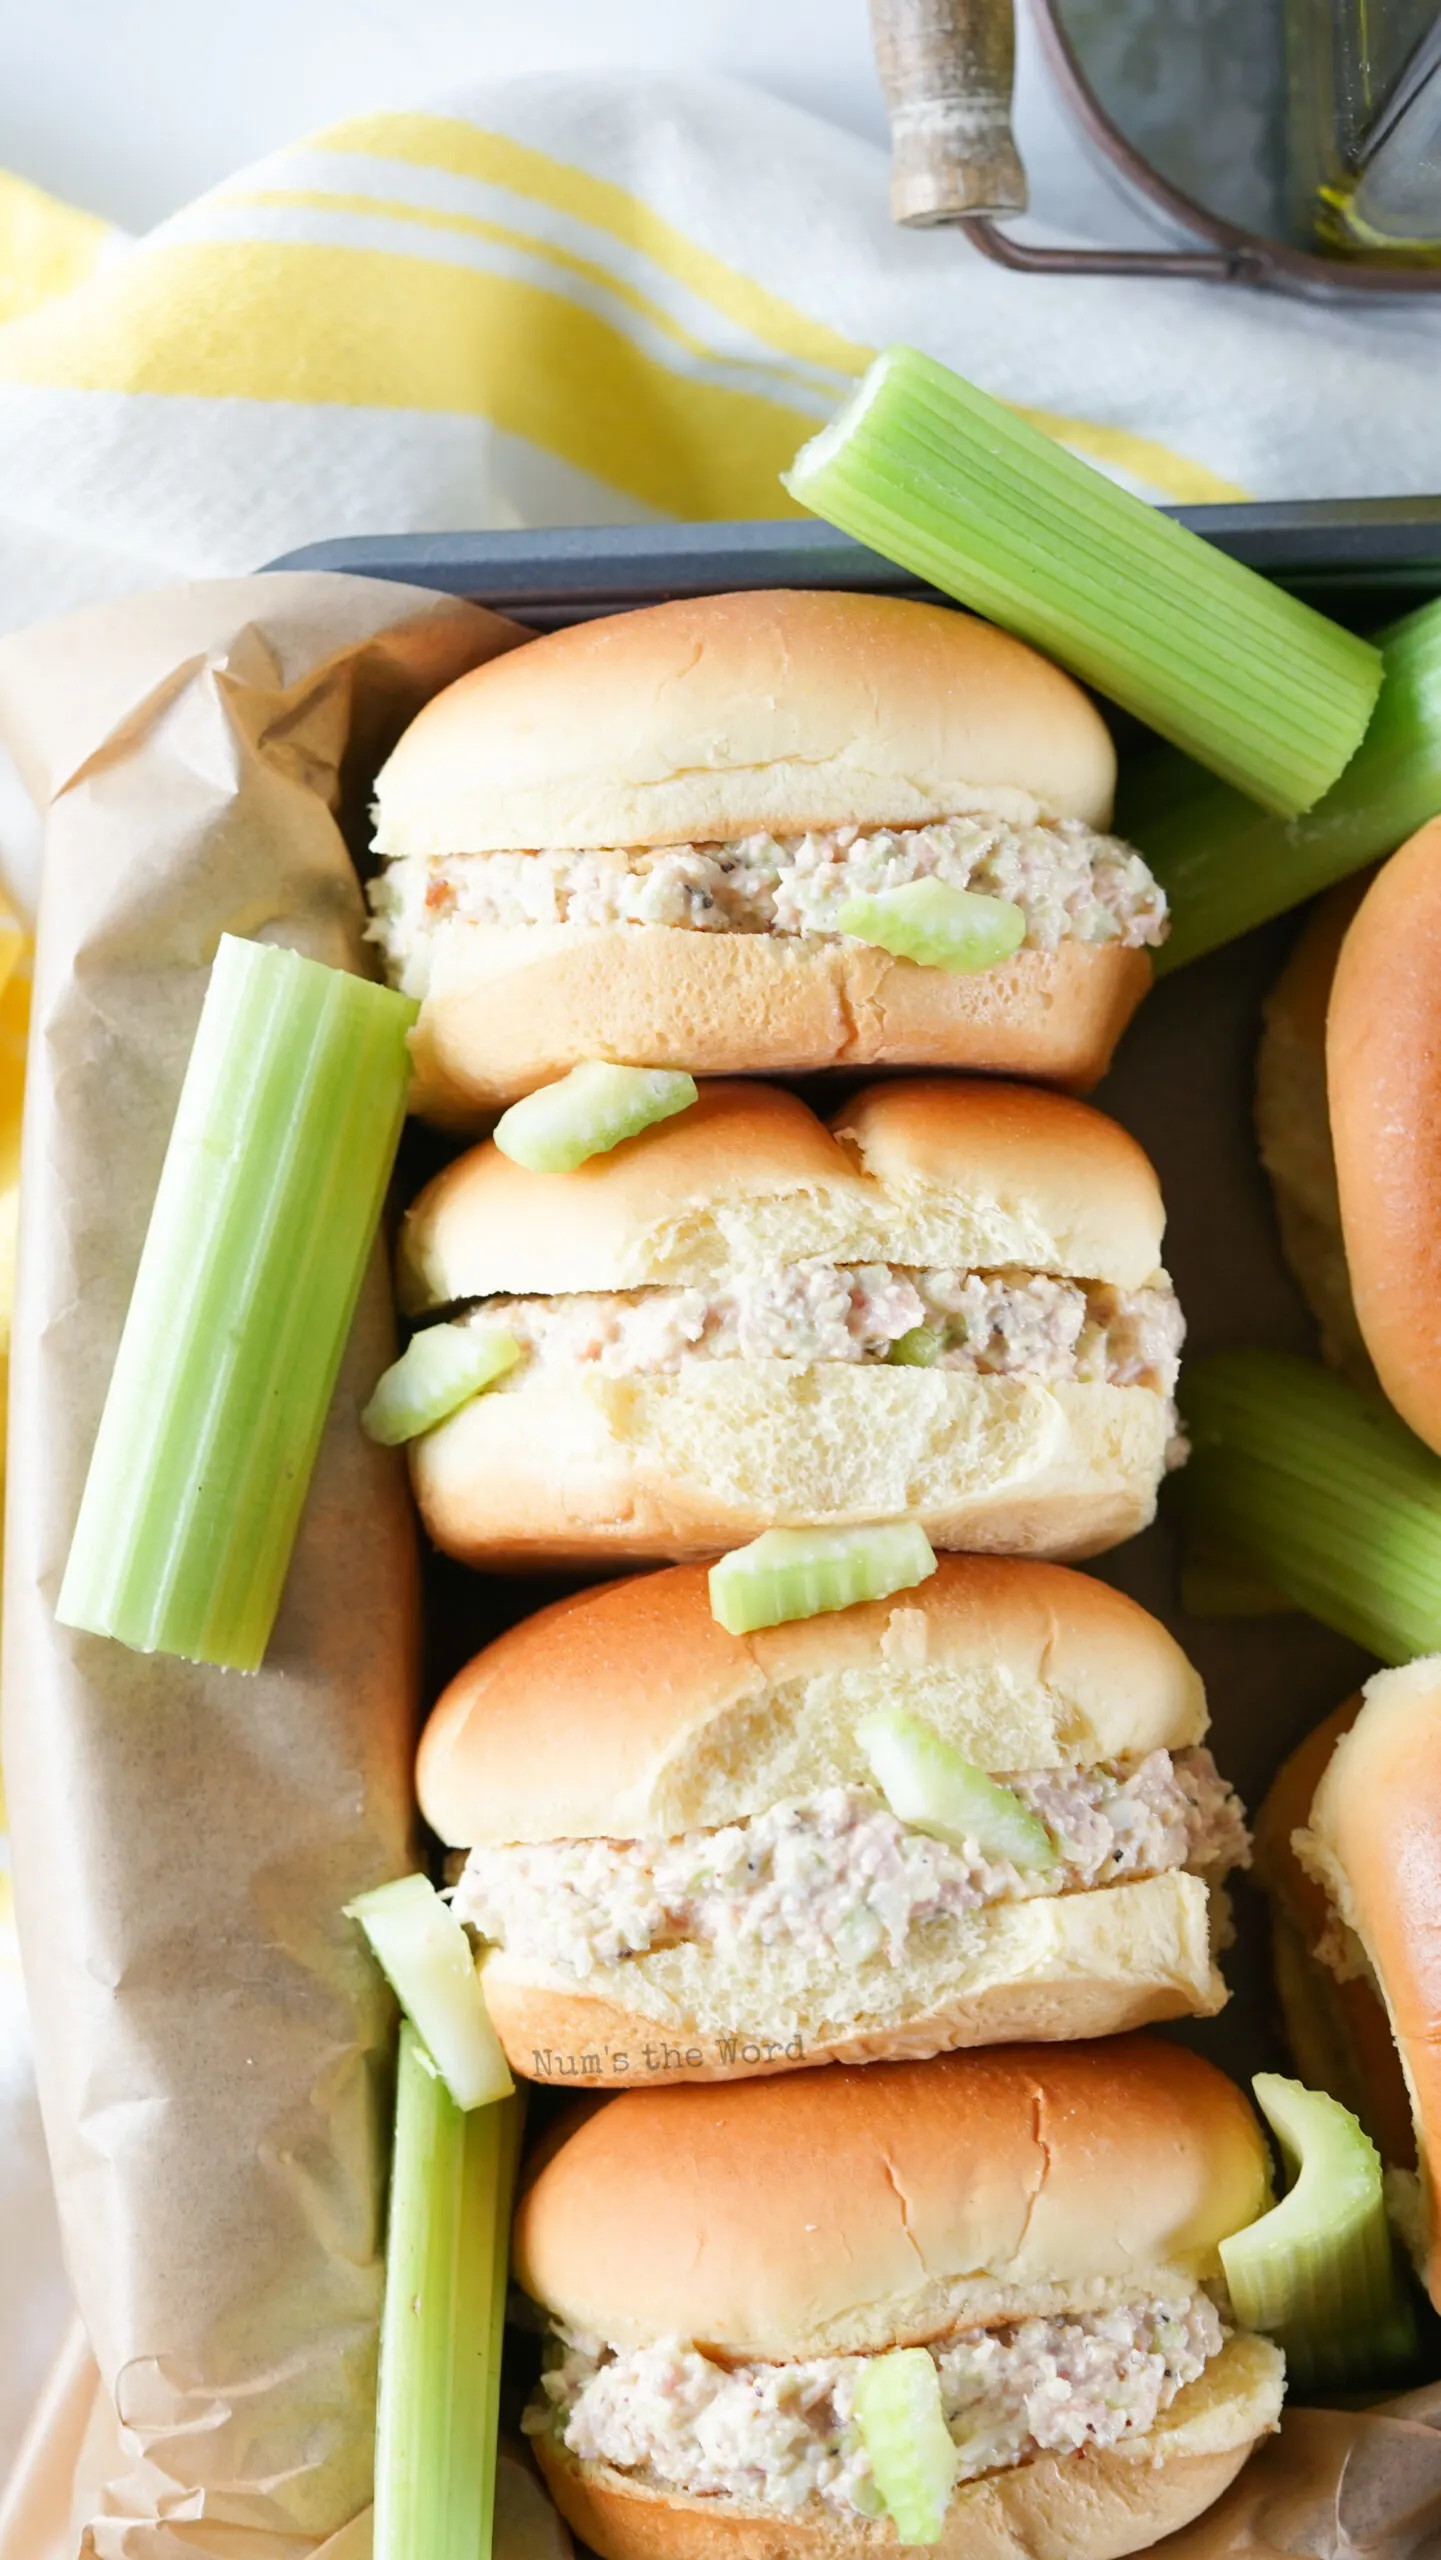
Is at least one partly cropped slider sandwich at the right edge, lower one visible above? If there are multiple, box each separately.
[1257,1659,1441,2309]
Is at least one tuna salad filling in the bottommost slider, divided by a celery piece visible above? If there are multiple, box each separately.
[522,2294,1226,2516]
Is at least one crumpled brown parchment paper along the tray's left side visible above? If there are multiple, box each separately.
[0,573,522,2560]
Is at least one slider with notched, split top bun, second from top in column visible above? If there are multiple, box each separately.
[399,1080,1182,1567]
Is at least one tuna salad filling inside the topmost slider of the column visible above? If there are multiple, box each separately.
[371,817,1167,996]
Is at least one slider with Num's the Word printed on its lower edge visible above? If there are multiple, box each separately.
[417,1556,1249,2089]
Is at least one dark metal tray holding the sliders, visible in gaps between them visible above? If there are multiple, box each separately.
[290,497,1441,2508]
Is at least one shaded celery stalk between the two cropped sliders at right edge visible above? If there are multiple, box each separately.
[1175,1352,1441,1661]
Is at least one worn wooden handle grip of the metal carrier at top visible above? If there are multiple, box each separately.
[870,0,1026,223]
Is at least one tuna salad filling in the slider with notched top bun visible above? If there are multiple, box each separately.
[460,1262,1185,1395]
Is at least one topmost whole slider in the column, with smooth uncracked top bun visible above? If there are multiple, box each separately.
[371,591,1165,1126]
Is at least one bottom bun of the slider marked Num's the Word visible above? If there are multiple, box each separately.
[481,1874,1226,2089]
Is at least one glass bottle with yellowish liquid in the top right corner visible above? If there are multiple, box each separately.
[1285,0,1441,266]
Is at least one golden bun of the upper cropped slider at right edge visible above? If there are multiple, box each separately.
[1326,819,1441,1449]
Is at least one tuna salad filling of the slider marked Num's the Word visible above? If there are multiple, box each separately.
[453,1751,1249,1979]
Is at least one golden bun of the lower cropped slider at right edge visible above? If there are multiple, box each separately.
[1298,1656,1441,2309]
